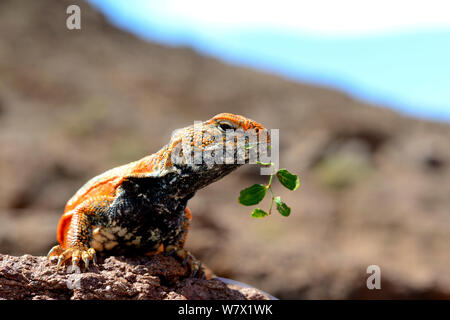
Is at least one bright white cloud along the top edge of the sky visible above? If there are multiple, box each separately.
[135,0,450,34]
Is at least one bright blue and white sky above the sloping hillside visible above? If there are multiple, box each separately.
[89,0,450,122]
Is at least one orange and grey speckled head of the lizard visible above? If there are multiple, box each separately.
[163,113,270,195]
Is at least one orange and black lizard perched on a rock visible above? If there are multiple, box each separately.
[47,113,270,277]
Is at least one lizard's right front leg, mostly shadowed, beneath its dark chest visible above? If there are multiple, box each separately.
[164,207,205,278]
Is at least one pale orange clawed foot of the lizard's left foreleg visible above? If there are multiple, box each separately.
[47,245,97,273]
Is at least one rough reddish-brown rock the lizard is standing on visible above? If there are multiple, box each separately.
[0,254,268,300]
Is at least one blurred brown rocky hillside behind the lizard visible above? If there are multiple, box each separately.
[0,0,450,299]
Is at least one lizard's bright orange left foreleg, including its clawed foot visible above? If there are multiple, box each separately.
[47,197,112,273]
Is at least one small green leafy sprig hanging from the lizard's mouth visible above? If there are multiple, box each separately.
[238,161,300,218]
